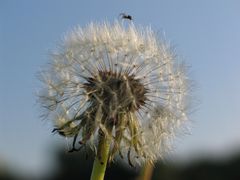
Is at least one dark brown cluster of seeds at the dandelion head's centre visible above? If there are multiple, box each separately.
[84,71,147,113]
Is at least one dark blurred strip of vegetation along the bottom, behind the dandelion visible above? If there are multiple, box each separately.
[0,148,240,180]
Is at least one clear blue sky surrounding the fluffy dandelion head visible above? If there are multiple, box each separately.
[0,0,240,177]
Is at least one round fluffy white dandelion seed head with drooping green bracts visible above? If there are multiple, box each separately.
[39,22,188,179]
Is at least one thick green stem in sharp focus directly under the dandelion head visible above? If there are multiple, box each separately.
[91,134,110,180]
